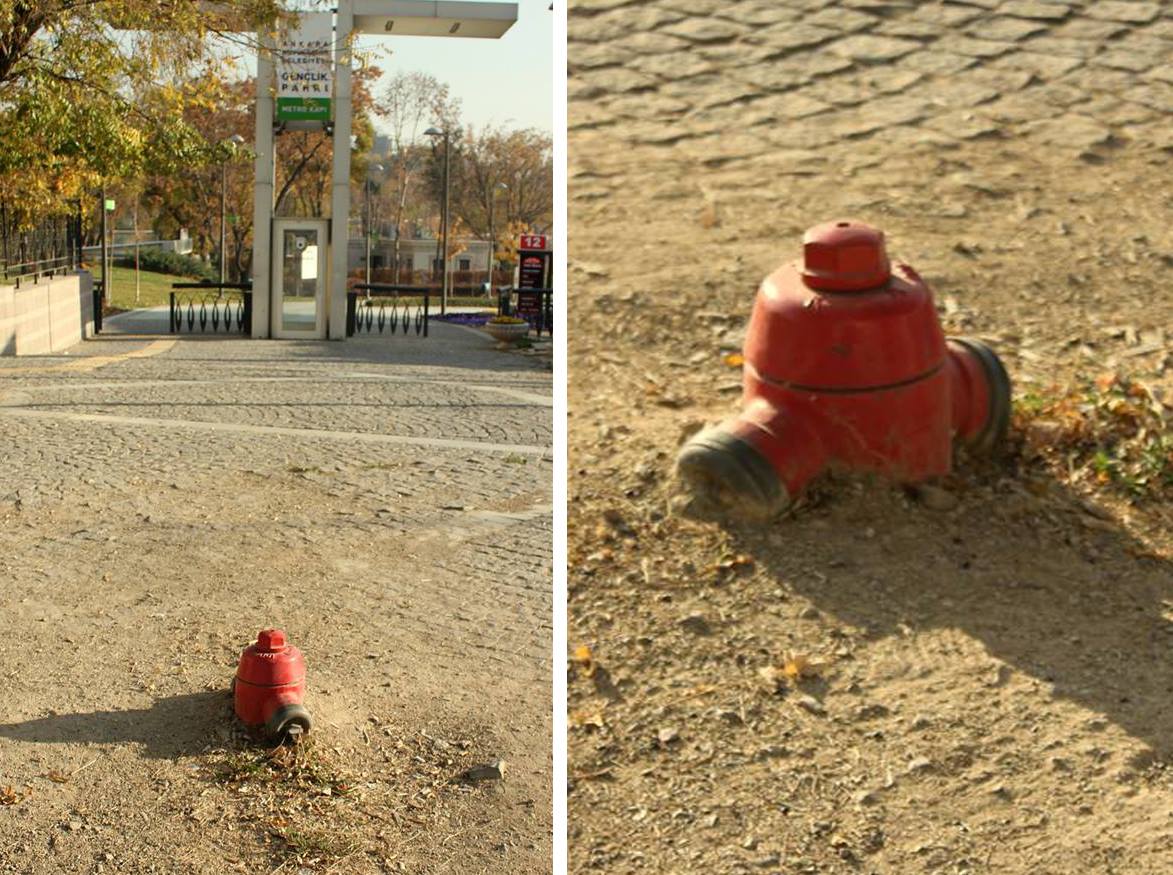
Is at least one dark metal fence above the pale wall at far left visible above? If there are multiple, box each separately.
[0,201,82,287]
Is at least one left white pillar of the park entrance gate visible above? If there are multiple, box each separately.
[252,33,277,338]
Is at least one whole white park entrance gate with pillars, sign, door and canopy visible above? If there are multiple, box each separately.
[252,0,518,340]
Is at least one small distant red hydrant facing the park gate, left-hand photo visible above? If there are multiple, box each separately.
[232,629,313,742]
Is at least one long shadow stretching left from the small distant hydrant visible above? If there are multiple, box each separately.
[0,690,232,759]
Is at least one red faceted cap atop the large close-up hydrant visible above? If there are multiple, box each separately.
[802,221,891,292]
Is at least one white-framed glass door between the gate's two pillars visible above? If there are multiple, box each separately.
[272,218,328,339]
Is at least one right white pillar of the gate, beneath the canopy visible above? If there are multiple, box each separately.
[327,0,354,340]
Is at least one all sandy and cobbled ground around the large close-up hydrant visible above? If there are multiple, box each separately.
[568,0,1173,875]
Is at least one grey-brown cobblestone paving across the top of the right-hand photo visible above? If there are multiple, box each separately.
[568,0,1173,164]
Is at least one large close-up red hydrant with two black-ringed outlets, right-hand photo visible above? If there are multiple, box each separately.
[677,222,1010,517]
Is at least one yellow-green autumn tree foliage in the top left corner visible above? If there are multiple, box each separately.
[0,0,282,212]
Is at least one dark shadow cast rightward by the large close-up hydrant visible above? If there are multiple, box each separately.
[724,466,1173,767]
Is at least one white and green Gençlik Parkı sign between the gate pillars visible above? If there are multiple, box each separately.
[277,12,334,122]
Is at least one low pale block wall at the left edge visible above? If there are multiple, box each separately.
[0,271,94,355]
